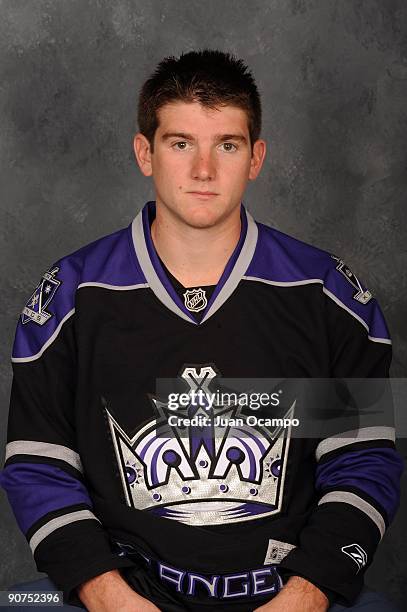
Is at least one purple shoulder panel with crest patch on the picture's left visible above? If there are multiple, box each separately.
[12,226,146,362]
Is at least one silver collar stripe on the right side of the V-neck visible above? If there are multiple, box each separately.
[201,210,259,323]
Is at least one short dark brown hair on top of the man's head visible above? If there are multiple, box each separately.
[138,49,261,151]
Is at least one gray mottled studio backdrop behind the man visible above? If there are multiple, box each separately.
[0,0,407,609]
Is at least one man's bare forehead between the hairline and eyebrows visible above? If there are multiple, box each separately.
[157,101,249,134]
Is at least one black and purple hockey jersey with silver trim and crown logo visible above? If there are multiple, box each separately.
[1,202,402,612]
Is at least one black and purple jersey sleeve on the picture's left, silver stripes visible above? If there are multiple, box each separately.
[0,261,133,603]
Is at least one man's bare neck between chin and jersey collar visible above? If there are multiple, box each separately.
[151,205,241,287]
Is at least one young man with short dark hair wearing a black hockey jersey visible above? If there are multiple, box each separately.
[2,51,401,612]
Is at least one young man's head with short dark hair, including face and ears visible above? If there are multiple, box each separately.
[134,51,265,228]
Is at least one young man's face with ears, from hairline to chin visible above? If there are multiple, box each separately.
[134,102,265,228]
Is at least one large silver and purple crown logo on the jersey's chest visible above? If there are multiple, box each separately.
[105,366,295,525]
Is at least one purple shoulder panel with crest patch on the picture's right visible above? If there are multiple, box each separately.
[245,223,389,340]
